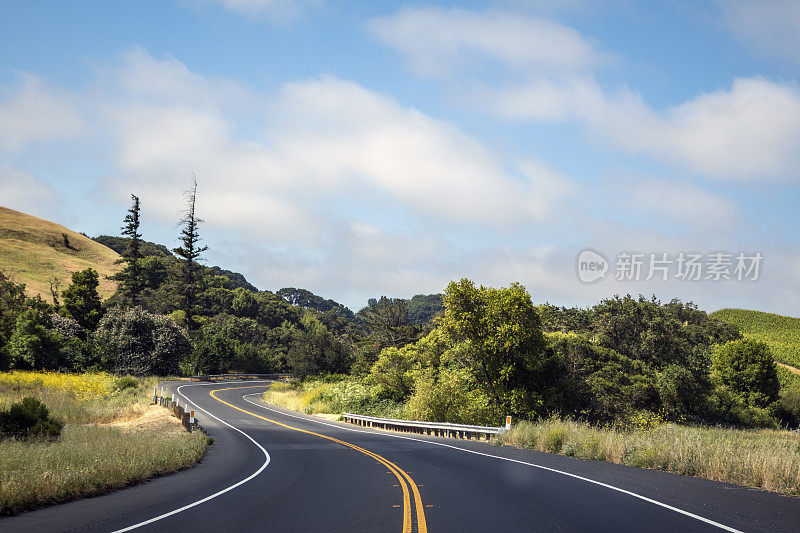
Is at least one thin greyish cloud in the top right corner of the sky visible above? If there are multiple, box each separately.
[716,0,800,61]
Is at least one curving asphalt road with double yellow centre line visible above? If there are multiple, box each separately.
[0,382,800,533]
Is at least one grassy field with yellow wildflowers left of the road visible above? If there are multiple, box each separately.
[0,372,206,514]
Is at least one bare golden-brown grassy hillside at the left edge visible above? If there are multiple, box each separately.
[0,206,122,301]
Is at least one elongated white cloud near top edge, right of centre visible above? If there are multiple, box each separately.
[369,8,604,76]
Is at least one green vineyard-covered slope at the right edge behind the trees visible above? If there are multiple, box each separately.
[711,309,800,368]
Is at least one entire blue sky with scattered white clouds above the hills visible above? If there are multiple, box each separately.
[0,0,800,316]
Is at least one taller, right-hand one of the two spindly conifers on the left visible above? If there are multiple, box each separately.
[172,174,208,329]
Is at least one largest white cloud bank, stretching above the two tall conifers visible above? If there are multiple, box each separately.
[79,50,572,236]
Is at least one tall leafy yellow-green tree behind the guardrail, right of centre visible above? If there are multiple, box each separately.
[441,279,547,416]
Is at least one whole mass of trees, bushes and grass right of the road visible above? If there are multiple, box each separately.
[263,280,800,495]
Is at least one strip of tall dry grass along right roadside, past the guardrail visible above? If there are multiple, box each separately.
[496,420,800,495]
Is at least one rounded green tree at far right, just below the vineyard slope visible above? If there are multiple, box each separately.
[711,339,781,407]
